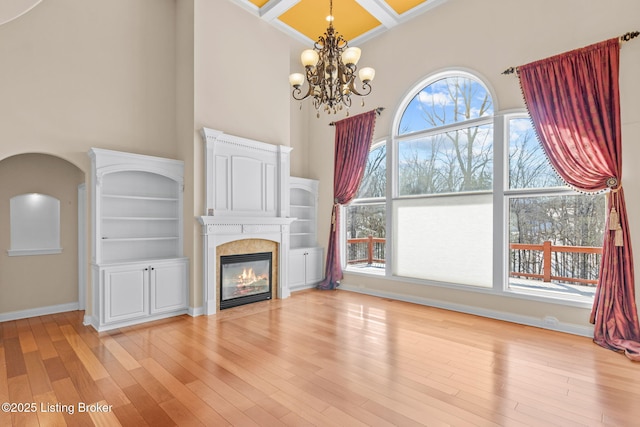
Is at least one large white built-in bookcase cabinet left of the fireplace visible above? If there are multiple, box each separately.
[89,148,188,331]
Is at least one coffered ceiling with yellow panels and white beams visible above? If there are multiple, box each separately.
[231,0,446,45]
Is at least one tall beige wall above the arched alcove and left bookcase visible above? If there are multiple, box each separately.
[0,0,178,311]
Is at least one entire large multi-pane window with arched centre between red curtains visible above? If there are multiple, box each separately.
[343,71,605,305]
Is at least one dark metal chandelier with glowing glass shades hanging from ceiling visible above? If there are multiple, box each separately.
[289,0,375,117]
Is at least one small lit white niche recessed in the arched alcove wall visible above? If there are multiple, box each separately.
[8,193,62,256]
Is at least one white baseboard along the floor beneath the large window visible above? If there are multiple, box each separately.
[338,284,593,337]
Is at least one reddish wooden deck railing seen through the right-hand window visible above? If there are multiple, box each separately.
[509,241,602,285]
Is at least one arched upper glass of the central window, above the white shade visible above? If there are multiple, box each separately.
[396,73,493,196]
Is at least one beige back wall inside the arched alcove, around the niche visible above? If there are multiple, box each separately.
[0,154,84,314]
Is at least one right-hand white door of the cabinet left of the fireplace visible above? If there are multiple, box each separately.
[150,261,187,314]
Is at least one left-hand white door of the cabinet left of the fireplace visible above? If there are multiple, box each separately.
[103,265,149,323]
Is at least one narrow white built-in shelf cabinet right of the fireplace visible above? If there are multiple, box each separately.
[289,177,324,291]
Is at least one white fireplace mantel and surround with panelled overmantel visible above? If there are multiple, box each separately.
[198,128,295,315]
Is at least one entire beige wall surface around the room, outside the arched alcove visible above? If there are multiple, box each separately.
[0,0,640,332]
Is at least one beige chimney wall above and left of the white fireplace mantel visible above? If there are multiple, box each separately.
[184,0,292,309]
